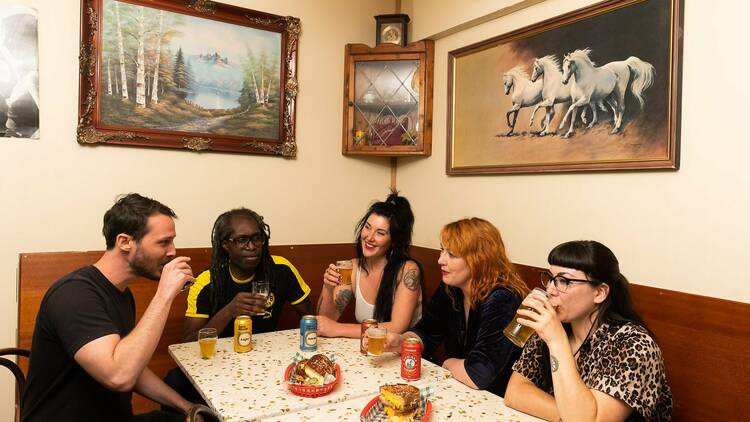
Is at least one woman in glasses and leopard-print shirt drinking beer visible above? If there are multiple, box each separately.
[505,241,672,421]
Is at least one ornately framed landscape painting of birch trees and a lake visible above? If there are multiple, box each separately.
[78,0,300,157]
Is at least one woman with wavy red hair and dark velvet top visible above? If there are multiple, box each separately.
[388,218,529,396]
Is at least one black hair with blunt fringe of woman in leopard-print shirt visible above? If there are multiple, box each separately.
[542,240,651,391]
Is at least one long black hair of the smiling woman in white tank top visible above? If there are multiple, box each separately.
[355,191,424,322]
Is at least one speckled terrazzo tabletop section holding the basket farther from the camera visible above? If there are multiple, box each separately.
[169,330,450,422]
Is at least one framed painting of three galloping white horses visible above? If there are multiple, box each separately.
[446,0,682,175]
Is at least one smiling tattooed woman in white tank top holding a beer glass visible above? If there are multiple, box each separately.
[318,192,422,338]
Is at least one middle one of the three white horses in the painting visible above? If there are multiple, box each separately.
[529,54,604,136]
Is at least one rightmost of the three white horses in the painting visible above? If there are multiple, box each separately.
[558,48,627,138]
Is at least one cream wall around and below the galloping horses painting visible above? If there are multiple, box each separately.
[398,0,750,302]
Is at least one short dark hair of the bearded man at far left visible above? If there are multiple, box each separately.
[102,193,177,250]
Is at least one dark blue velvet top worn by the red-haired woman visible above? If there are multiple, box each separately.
[411,282,521,396]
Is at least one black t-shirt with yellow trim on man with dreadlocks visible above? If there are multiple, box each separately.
[185,255,310,337]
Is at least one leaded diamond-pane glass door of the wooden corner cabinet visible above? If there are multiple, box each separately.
[351,60,419,146]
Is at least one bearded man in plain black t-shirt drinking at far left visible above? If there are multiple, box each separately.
[21,193,194,422]
